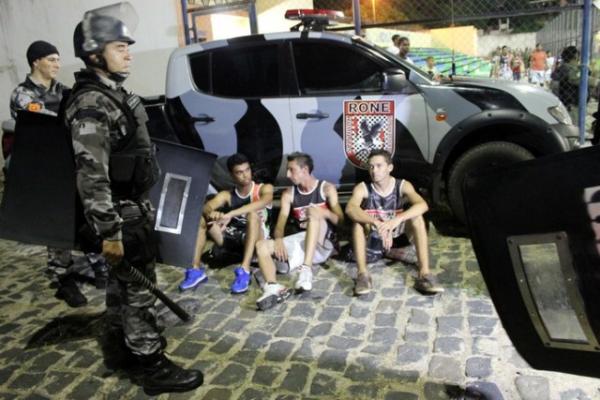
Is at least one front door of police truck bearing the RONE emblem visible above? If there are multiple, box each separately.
[289,38,429,191]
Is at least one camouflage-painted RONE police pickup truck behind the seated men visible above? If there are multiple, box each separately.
[149,10,578,221]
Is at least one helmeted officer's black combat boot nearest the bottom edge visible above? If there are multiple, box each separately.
[138,351,204,396]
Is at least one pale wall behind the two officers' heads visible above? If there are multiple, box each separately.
[0,0,180,121]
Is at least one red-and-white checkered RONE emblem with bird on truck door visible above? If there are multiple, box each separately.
[344,100,396,169]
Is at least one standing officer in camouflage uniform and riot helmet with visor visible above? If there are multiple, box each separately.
[65,12,203,395]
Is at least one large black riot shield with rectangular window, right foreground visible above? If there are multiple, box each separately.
[463,147,600,377]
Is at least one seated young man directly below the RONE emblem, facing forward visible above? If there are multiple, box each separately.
[346,150,444,295]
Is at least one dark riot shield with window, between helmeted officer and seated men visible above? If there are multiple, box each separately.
[150,139,217,267]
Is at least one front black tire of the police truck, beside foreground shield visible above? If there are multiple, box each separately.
[447,142,534,224]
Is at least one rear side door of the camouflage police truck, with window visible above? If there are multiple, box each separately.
[182,41,292,188]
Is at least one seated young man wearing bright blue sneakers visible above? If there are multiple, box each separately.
[179,153,273,293]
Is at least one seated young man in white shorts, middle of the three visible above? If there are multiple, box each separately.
[256,152,344,310]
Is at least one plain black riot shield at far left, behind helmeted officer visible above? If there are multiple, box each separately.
[0,111,76,248]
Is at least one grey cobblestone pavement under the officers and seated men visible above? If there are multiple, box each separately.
[0,225,600,400]
